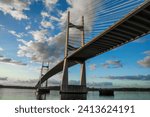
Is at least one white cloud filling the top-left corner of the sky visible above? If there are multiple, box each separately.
[0,0,30,20]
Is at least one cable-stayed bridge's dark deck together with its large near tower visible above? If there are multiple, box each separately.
[36,0,150,93]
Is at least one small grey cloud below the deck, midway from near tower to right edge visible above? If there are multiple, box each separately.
[102,60,123,68]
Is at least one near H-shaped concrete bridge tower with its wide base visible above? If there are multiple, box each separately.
[60,12,87,94]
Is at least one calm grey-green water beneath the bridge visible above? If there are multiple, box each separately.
[0,88,150,100]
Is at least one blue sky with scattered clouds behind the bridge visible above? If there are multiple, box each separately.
[0,0,150,87]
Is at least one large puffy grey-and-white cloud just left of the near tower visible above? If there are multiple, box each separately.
[18,30,64,63]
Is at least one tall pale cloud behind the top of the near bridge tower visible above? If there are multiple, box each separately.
[59,0,95,34]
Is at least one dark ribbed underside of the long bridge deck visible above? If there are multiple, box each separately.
[36,1,150,87]
